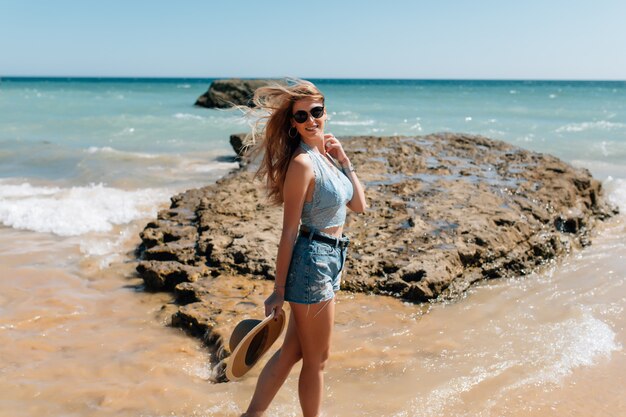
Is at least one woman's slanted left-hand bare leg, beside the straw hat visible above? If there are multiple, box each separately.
[244,312,302,417]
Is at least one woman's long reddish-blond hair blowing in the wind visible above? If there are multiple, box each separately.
[246,79,324,204]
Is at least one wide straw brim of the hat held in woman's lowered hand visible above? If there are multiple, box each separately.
[226,311,285,381]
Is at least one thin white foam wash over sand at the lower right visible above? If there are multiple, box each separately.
[396,311,622,416]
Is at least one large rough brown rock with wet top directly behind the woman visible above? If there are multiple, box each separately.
[138,134,615,380]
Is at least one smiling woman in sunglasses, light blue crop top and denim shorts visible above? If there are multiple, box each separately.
[244,80,366,417]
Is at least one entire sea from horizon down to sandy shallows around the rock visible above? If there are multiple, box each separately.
[0,77,626,416]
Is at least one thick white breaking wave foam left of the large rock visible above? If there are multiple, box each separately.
[0,183,169,236]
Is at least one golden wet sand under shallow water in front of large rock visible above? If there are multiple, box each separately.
[0,216,626,417]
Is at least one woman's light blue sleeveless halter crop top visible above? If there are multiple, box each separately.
[300,142,354,230]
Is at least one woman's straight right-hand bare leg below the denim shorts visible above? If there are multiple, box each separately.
[290,299,335,417]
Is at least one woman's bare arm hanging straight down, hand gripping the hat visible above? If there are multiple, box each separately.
[265,154,314,316]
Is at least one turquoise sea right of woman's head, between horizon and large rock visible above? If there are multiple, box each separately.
[322,81,626,175]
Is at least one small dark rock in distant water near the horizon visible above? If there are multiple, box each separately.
[195,78,271,109]
